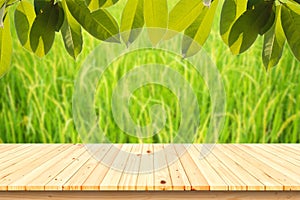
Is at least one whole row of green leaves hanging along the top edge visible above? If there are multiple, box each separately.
[0,0,300,77]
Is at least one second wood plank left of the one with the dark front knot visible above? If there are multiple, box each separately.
[118,144,143,191]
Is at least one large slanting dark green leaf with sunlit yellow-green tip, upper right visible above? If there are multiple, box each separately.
[229,2,273,54]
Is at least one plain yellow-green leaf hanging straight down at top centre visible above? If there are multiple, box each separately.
[144,0,168,45]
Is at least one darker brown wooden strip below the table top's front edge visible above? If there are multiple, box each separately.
[0,191,300,200]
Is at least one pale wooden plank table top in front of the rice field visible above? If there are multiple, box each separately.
[0,144,300,191]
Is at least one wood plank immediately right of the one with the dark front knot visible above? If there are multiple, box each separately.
[164,144,192,190]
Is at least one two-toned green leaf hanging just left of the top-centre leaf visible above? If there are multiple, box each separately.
[120,0,144,44]
